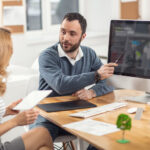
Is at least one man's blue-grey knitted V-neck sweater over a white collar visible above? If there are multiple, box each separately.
[39,44,113,96]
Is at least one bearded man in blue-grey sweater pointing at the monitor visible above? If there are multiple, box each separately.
[30,13,117,149]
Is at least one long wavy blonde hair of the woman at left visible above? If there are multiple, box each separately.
[0,27,12,96]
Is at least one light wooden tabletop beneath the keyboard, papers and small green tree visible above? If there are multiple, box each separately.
[36,90,150,150]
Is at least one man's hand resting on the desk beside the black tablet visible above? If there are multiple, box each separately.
[73,89,96,100]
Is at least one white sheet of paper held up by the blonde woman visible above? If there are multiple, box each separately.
[13,90,52,110]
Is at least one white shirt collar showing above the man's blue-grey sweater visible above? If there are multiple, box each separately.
[58,44,83,65]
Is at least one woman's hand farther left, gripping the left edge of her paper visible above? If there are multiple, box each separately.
[4,99,22,117]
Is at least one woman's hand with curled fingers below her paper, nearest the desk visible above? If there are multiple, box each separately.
[12,109,39,126]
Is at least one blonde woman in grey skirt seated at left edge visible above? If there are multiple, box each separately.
[0,28,53,150]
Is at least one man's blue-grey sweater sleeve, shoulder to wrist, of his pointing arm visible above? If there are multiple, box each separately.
[39,50,95,95]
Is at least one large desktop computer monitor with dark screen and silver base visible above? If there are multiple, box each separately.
[108,20,150,102]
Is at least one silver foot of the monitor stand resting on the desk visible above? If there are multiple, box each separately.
[126,92,150,103]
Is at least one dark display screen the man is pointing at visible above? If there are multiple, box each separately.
[108,20,150,78]
